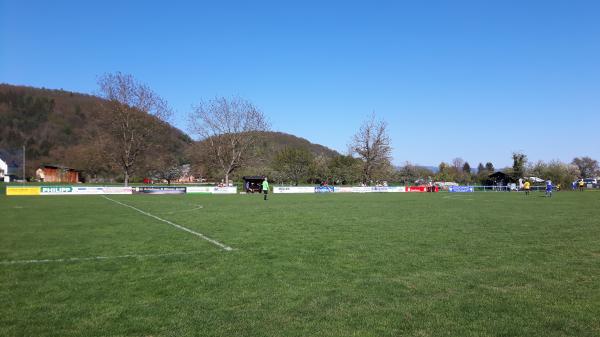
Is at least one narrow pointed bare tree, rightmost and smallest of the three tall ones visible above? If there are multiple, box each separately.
[350,113,392,183]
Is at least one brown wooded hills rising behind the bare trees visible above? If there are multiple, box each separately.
[0,84,338,181]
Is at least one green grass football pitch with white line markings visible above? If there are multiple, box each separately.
[0,192,600,337]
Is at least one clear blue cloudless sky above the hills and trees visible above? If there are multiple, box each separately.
[0,0,600,167]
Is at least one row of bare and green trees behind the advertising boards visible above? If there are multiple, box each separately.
[92,73,600,185]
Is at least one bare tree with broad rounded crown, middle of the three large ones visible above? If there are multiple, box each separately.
[189,97,269,183]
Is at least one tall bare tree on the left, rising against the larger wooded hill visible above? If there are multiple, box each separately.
[98,72,171,186]
